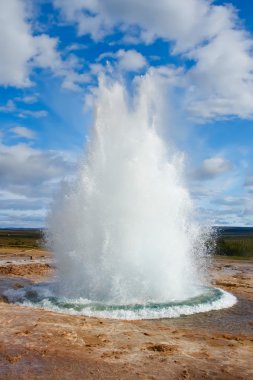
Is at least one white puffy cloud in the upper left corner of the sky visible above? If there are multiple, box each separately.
[0,0,80,89]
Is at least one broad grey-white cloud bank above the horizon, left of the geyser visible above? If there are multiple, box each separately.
[0,142,76,227]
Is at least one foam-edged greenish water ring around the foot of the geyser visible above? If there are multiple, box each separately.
[5,284,236,320]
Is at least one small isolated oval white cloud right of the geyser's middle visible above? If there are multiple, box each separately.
[193,157,233,180]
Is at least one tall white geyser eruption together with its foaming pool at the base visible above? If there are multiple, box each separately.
[5,76,235,319]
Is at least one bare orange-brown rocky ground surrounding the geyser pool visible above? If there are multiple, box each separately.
[0,248,253,380]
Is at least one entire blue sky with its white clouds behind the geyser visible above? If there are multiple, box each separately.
[0,0,253,227]
